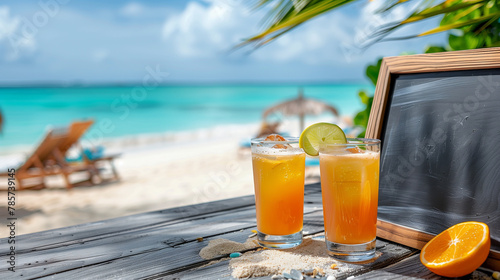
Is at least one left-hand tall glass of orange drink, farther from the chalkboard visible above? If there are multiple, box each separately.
[251,138,306,249]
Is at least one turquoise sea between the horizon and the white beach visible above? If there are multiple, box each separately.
[0,84,373,150]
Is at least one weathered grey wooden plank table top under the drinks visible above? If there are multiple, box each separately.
[0,184,492,279]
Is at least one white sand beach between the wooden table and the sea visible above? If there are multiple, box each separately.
[0,117,356,237]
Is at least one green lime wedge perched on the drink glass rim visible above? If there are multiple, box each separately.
[299,123,347,156]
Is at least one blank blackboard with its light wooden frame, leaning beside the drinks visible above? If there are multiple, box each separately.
[367,48,500,269]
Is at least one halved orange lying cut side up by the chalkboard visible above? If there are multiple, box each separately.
[420,222,491,277]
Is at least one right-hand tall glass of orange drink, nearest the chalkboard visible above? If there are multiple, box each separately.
[319,138,380,262]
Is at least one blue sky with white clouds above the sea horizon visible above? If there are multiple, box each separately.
[0,0,446,85]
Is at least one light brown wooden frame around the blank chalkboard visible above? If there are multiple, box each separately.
[366,48,500,270]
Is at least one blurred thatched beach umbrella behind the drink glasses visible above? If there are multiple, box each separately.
[262,89,339,131]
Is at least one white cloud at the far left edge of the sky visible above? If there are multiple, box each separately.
[0,6,36,61]
